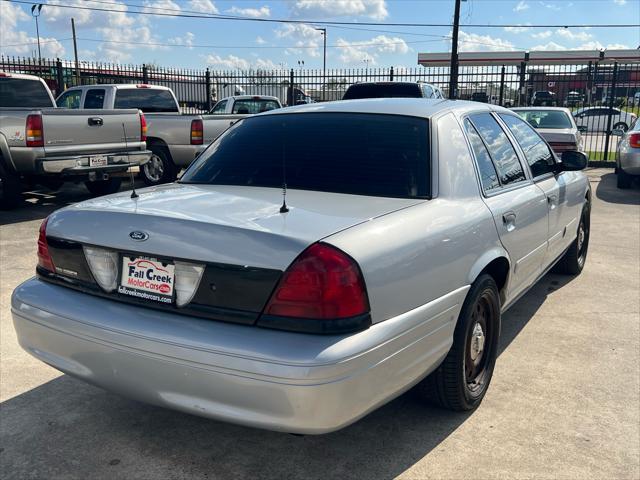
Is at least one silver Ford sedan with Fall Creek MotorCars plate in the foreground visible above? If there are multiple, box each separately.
[12,99,591,434]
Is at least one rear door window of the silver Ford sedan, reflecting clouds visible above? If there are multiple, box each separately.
[469,113,526,185]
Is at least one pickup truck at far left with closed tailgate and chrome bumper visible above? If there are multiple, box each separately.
[0,72,151,208]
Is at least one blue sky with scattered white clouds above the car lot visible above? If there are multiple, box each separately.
[0,0,640,69]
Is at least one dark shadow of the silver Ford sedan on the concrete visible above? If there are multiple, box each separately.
[0,274,572,479]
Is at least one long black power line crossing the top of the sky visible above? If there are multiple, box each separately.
[3,0,640,28]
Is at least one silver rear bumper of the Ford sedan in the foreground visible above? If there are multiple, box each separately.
[12,279,468,434]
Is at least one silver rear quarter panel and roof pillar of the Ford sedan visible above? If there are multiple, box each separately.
[325,110,504,323]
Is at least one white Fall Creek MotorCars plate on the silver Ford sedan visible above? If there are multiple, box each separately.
[118,255,175,303]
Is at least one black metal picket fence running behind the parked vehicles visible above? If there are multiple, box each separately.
[0,57,640,161]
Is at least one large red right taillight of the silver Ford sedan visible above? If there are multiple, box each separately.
[264,243,369,320]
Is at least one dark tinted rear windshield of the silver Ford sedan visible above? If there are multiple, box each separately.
[181,113,430,198]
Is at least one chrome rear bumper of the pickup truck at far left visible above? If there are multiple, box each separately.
[40,150,151,175]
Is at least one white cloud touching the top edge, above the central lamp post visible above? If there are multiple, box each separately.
[291,0,389,20]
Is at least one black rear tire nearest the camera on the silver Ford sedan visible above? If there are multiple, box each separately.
[416,274,501,411]
